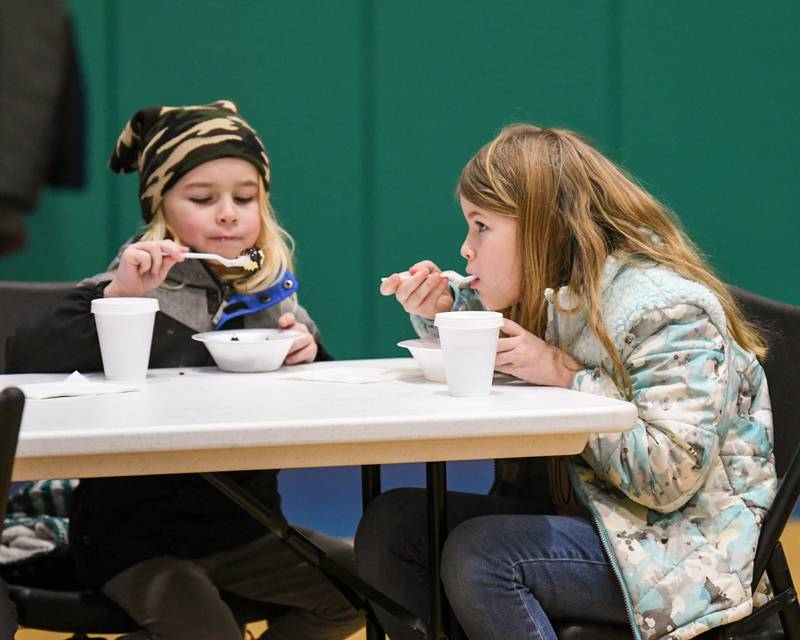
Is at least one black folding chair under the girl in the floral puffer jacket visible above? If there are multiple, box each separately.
[556,287,800,640]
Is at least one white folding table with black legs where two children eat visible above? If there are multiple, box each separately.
[0,359,636,638]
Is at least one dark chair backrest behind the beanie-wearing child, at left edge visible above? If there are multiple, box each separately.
[0,281,75,372]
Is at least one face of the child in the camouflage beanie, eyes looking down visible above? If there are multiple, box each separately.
[164,158,261,258]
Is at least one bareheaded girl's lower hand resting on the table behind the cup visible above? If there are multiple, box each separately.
[494,319,583,389]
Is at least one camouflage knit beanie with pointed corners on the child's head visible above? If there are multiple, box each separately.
[108,100,269,223]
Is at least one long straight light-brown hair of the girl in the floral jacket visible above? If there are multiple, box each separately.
[457,124,767,395]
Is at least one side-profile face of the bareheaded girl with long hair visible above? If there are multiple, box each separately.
[461,196,522,309]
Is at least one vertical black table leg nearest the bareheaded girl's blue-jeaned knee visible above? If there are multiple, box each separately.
[425,462,449,640]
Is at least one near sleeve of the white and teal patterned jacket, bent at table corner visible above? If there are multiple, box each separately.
[572,304,728,513]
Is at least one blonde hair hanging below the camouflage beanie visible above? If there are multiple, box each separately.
[142,180,294,293]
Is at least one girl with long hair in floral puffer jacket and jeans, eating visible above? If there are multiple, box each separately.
[356,124,776,640]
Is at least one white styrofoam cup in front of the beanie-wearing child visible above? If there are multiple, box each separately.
[92,298,158,380]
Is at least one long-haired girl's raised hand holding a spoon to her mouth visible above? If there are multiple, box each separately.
[381,260,453,320]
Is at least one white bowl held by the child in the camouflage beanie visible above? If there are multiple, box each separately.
[192,329,302,373]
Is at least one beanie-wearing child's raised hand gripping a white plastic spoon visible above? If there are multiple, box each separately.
[103,240,189,298]
